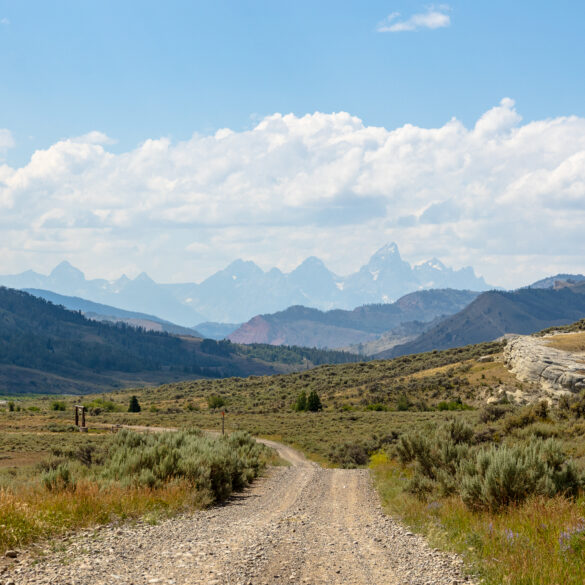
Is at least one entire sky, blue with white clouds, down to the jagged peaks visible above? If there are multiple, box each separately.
[0,0,585,288]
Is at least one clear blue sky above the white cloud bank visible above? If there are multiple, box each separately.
[0,0,585,163]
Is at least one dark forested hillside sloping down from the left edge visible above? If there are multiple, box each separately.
[0,287,356,394]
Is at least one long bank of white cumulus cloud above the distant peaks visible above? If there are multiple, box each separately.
[0,98,585,286]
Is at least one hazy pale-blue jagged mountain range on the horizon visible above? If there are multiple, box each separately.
[0,243,490,327]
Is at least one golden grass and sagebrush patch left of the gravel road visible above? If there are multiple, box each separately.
[0,410,276,551]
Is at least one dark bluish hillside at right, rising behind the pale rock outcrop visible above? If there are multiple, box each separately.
[376,283,585,359]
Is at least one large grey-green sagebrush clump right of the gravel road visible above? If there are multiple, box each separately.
[395,418,582,510]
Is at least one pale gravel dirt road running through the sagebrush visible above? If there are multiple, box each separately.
[5,441,471,585]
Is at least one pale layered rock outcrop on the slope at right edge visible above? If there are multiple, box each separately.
[504,335,585,397]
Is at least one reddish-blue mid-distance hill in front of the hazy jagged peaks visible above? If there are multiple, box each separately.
[228,289,479,348]
